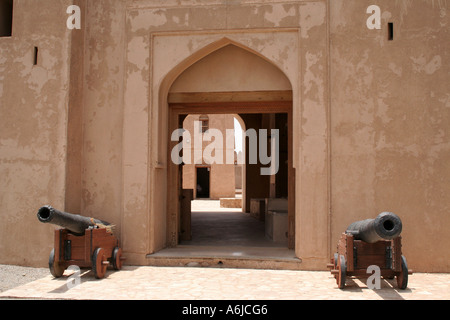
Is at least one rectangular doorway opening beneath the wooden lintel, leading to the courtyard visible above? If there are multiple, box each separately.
[163,101,299,268]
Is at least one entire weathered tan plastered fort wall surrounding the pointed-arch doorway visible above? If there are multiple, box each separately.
[0,0,450,272]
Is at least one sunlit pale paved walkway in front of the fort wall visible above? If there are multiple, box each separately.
[0,266,450,300]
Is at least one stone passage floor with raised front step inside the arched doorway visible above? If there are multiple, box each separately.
[147,200,301,270]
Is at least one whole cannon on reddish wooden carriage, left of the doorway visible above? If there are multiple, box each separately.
[37,206,125,279]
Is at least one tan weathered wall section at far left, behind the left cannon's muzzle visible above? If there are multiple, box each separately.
[0,0,70,265]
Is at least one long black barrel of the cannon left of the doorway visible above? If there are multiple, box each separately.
[37,206,110,235]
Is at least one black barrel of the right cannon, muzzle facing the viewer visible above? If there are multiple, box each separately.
[346,212,402,243]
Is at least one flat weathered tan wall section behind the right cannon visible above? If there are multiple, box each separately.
[330,0,450,272]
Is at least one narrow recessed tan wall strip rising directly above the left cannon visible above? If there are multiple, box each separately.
[77,0,126,242]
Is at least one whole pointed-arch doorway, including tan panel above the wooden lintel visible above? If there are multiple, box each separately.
[151,43,299,267]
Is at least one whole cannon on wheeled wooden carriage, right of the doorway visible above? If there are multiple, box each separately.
[327,212,412,290]
